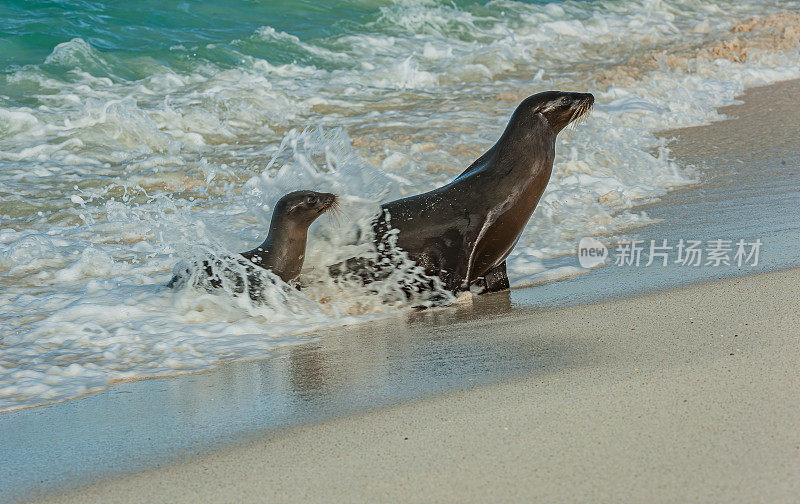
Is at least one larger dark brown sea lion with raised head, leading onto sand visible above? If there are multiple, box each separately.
[373,91,594,293]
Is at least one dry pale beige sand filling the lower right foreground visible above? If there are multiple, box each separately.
[32,269,800,503]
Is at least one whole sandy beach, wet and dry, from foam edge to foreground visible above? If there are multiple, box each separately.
[14,81,800,502]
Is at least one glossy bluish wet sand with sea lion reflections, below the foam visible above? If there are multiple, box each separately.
[0,292,596,497]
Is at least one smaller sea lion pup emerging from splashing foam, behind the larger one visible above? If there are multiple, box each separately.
[168,191,338,301]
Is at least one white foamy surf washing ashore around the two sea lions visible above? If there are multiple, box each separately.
[0,0,800,410]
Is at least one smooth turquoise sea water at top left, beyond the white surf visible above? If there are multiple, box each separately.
[0,0,564,78]
